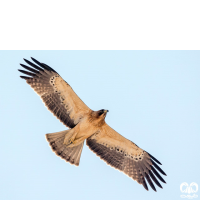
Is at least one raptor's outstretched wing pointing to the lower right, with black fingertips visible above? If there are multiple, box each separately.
[87,124,166,191]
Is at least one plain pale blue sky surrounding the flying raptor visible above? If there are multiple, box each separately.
[0,51,200,200]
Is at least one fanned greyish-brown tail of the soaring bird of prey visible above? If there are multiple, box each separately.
[46,130,84,166]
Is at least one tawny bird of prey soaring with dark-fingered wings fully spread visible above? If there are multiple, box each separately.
[19,58,166,191]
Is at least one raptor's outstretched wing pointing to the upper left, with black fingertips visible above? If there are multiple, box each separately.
[19,58,91,128]
